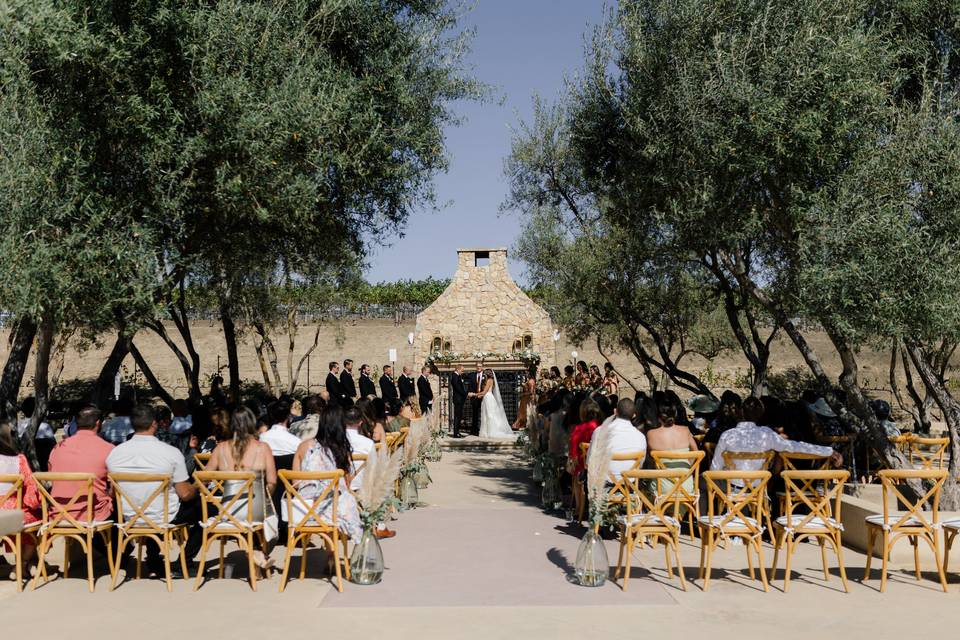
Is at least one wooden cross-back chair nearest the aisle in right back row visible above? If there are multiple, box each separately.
[616,469,688,591]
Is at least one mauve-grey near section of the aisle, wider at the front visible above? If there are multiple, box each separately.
[320,507,675,607]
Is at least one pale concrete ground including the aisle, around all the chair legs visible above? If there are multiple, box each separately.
[0,451,960,640]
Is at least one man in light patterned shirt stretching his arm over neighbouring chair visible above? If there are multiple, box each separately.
[710,398,843,471]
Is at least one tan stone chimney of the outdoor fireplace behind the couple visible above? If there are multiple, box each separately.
[414,249,554,364]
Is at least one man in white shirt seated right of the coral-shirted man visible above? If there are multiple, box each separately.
[107,404,200,575]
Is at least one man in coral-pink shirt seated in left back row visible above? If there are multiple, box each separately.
[50,405,113,524]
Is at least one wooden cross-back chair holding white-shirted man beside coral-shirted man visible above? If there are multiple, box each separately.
[107,473,188,591]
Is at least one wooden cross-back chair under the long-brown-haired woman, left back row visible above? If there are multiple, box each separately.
[193,471,270,591]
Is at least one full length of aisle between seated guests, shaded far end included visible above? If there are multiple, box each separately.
[322,451,674,608]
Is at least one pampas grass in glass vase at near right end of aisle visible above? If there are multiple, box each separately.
[574,429,613,587]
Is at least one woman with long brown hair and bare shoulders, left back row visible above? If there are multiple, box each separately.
[206,406,277,571]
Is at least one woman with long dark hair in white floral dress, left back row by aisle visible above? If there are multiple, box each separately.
[286,407,370,543]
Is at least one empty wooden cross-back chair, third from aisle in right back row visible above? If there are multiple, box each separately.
[770,469,850,593]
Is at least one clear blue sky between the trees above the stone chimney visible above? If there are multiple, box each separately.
[366,0,612,282]
